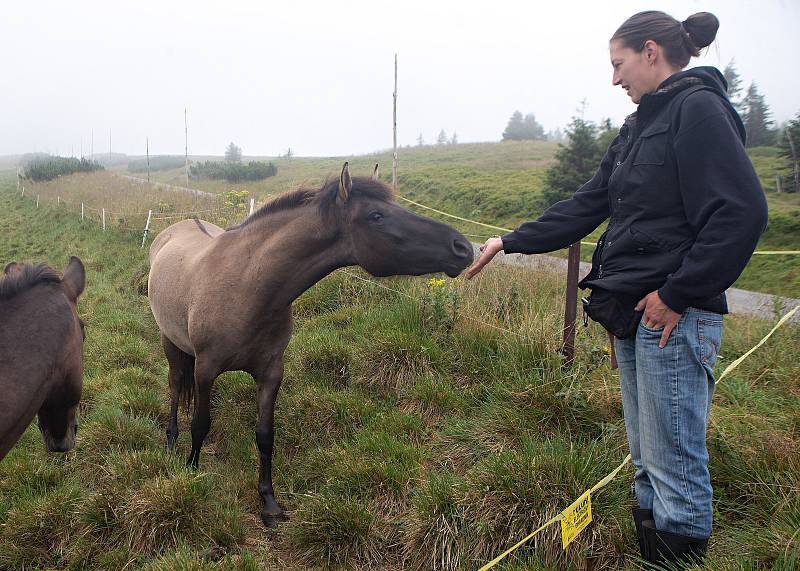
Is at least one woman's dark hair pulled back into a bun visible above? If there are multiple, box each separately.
[611,10,719,68]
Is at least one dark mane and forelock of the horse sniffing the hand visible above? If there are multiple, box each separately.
[230,177,394,230]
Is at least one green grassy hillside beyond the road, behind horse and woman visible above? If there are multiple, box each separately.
[126,141,800,297]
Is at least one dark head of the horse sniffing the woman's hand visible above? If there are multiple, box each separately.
[336,163,473,277]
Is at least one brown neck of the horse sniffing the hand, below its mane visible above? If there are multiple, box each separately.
[230,205,353,310]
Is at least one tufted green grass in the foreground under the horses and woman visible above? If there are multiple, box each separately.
[0,171,800,571]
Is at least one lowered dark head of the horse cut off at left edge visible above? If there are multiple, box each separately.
[38,256,86,452]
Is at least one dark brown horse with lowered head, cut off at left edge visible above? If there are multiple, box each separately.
[0,256,86,460]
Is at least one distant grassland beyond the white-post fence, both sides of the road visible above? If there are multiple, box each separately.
[9,141,800,297]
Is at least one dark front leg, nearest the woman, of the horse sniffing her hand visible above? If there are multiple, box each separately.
[255,355,286,527]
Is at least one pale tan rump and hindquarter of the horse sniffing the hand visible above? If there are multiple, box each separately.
[147,220,225,354]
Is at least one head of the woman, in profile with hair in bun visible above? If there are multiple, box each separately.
[609,10,719,103]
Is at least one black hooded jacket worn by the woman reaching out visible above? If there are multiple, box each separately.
[503,67,767,313]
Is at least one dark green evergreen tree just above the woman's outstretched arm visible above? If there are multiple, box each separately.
[541,117,605,208]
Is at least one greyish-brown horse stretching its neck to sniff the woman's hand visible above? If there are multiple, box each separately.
[148,163,473,525]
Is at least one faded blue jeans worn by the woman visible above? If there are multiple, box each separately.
[614,307,722,539]
